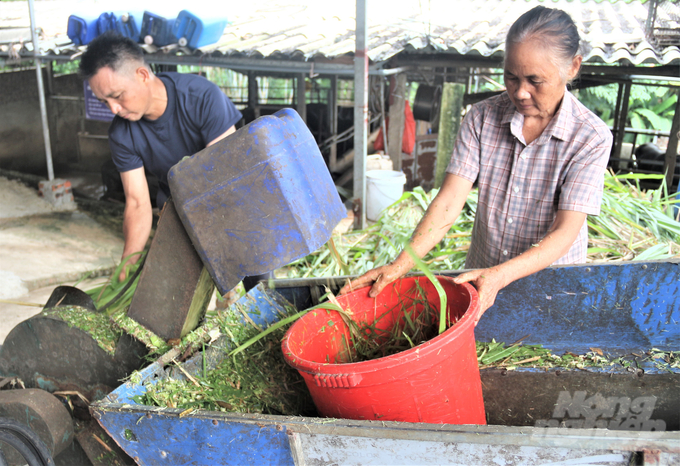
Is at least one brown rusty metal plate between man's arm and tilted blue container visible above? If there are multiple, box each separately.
[128,199,211,340]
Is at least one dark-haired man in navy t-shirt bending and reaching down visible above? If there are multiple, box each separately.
[80,33,241,279]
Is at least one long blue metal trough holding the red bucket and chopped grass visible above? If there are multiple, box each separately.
[90,261,680,465]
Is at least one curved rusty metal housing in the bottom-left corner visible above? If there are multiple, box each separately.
[0,389,74,464]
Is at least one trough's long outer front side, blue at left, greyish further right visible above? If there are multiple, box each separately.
[92,402,680,466]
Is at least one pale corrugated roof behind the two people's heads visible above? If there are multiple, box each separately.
[0,0,680,65]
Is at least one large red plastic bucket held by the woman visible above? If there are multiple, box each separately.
[282,277,486,424]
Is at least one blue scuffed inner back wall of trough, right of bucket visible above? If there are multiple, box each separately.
[475,261,680,354]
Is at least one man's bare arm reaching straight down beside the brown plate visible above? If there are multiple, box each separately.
[119,167,153,281]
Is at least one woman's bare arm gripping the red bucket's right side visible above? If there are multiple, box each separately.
[454,210,587,325]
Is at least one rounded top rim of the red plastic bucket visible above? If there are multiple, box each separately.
[281,276,479,374]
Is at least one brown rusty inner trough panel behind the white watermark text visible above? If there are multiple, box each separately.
[480,369,680,431]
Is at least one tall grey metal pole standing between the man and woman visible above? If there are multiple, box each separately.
[353,0,368,229]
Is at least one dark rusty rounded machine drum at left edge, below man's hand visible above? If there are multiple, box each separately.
[0,313,147,400]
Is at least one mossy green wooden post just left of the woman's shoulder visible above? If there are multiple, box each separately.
[434,83,465,188]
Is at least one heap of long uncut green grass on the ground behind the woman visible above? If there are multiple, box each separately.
[277,173,680,278]
